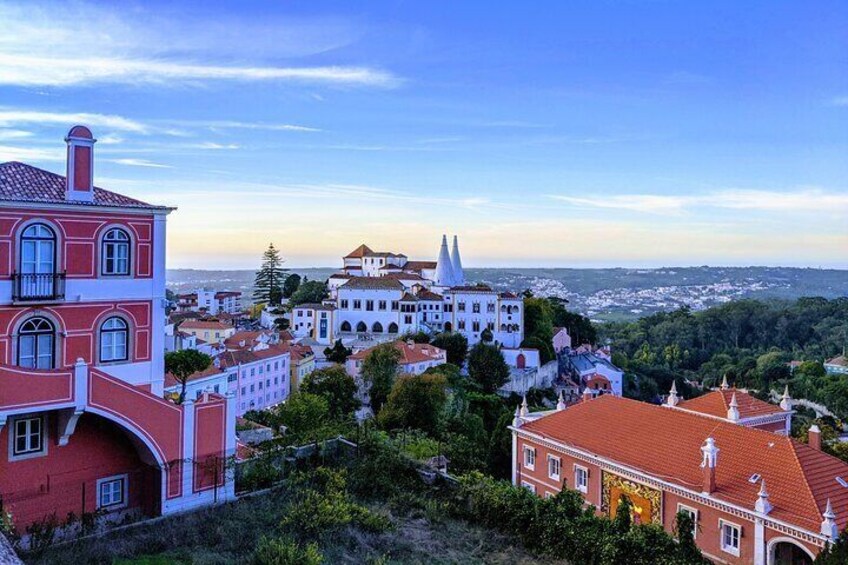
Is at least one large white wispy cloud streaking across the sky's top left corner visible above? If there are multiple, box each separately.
[0,3,400,87]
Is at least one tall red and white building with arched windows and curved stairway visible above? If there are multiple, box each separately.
[0,126,236,531]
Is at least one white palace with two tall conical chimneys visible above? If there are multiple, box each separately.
[290,236,524,347]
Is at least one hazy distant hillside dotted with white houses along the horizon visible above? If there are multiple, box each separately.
[168,267,848,320]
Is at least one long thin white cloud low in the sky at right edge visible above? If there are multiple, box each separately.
[548,187,848,215]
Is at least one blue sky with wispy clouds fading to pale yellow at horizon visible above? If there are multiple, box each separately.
[0,0,848,269]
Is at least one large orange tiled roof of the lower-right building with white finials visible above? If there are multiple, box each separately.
[520,395,848,532]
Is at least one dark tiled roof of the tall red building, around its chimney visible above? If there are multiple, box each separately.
[0,161,168,210]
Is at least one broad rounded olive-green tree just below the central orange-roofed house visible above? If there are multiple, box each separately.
[378,374,447,435]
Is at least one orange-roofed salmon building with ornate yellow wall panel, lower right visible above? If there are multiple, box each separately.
[512,390,848,565]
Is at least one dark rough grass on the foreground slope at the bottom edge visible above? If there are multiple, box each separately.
[24,490,542,565]
